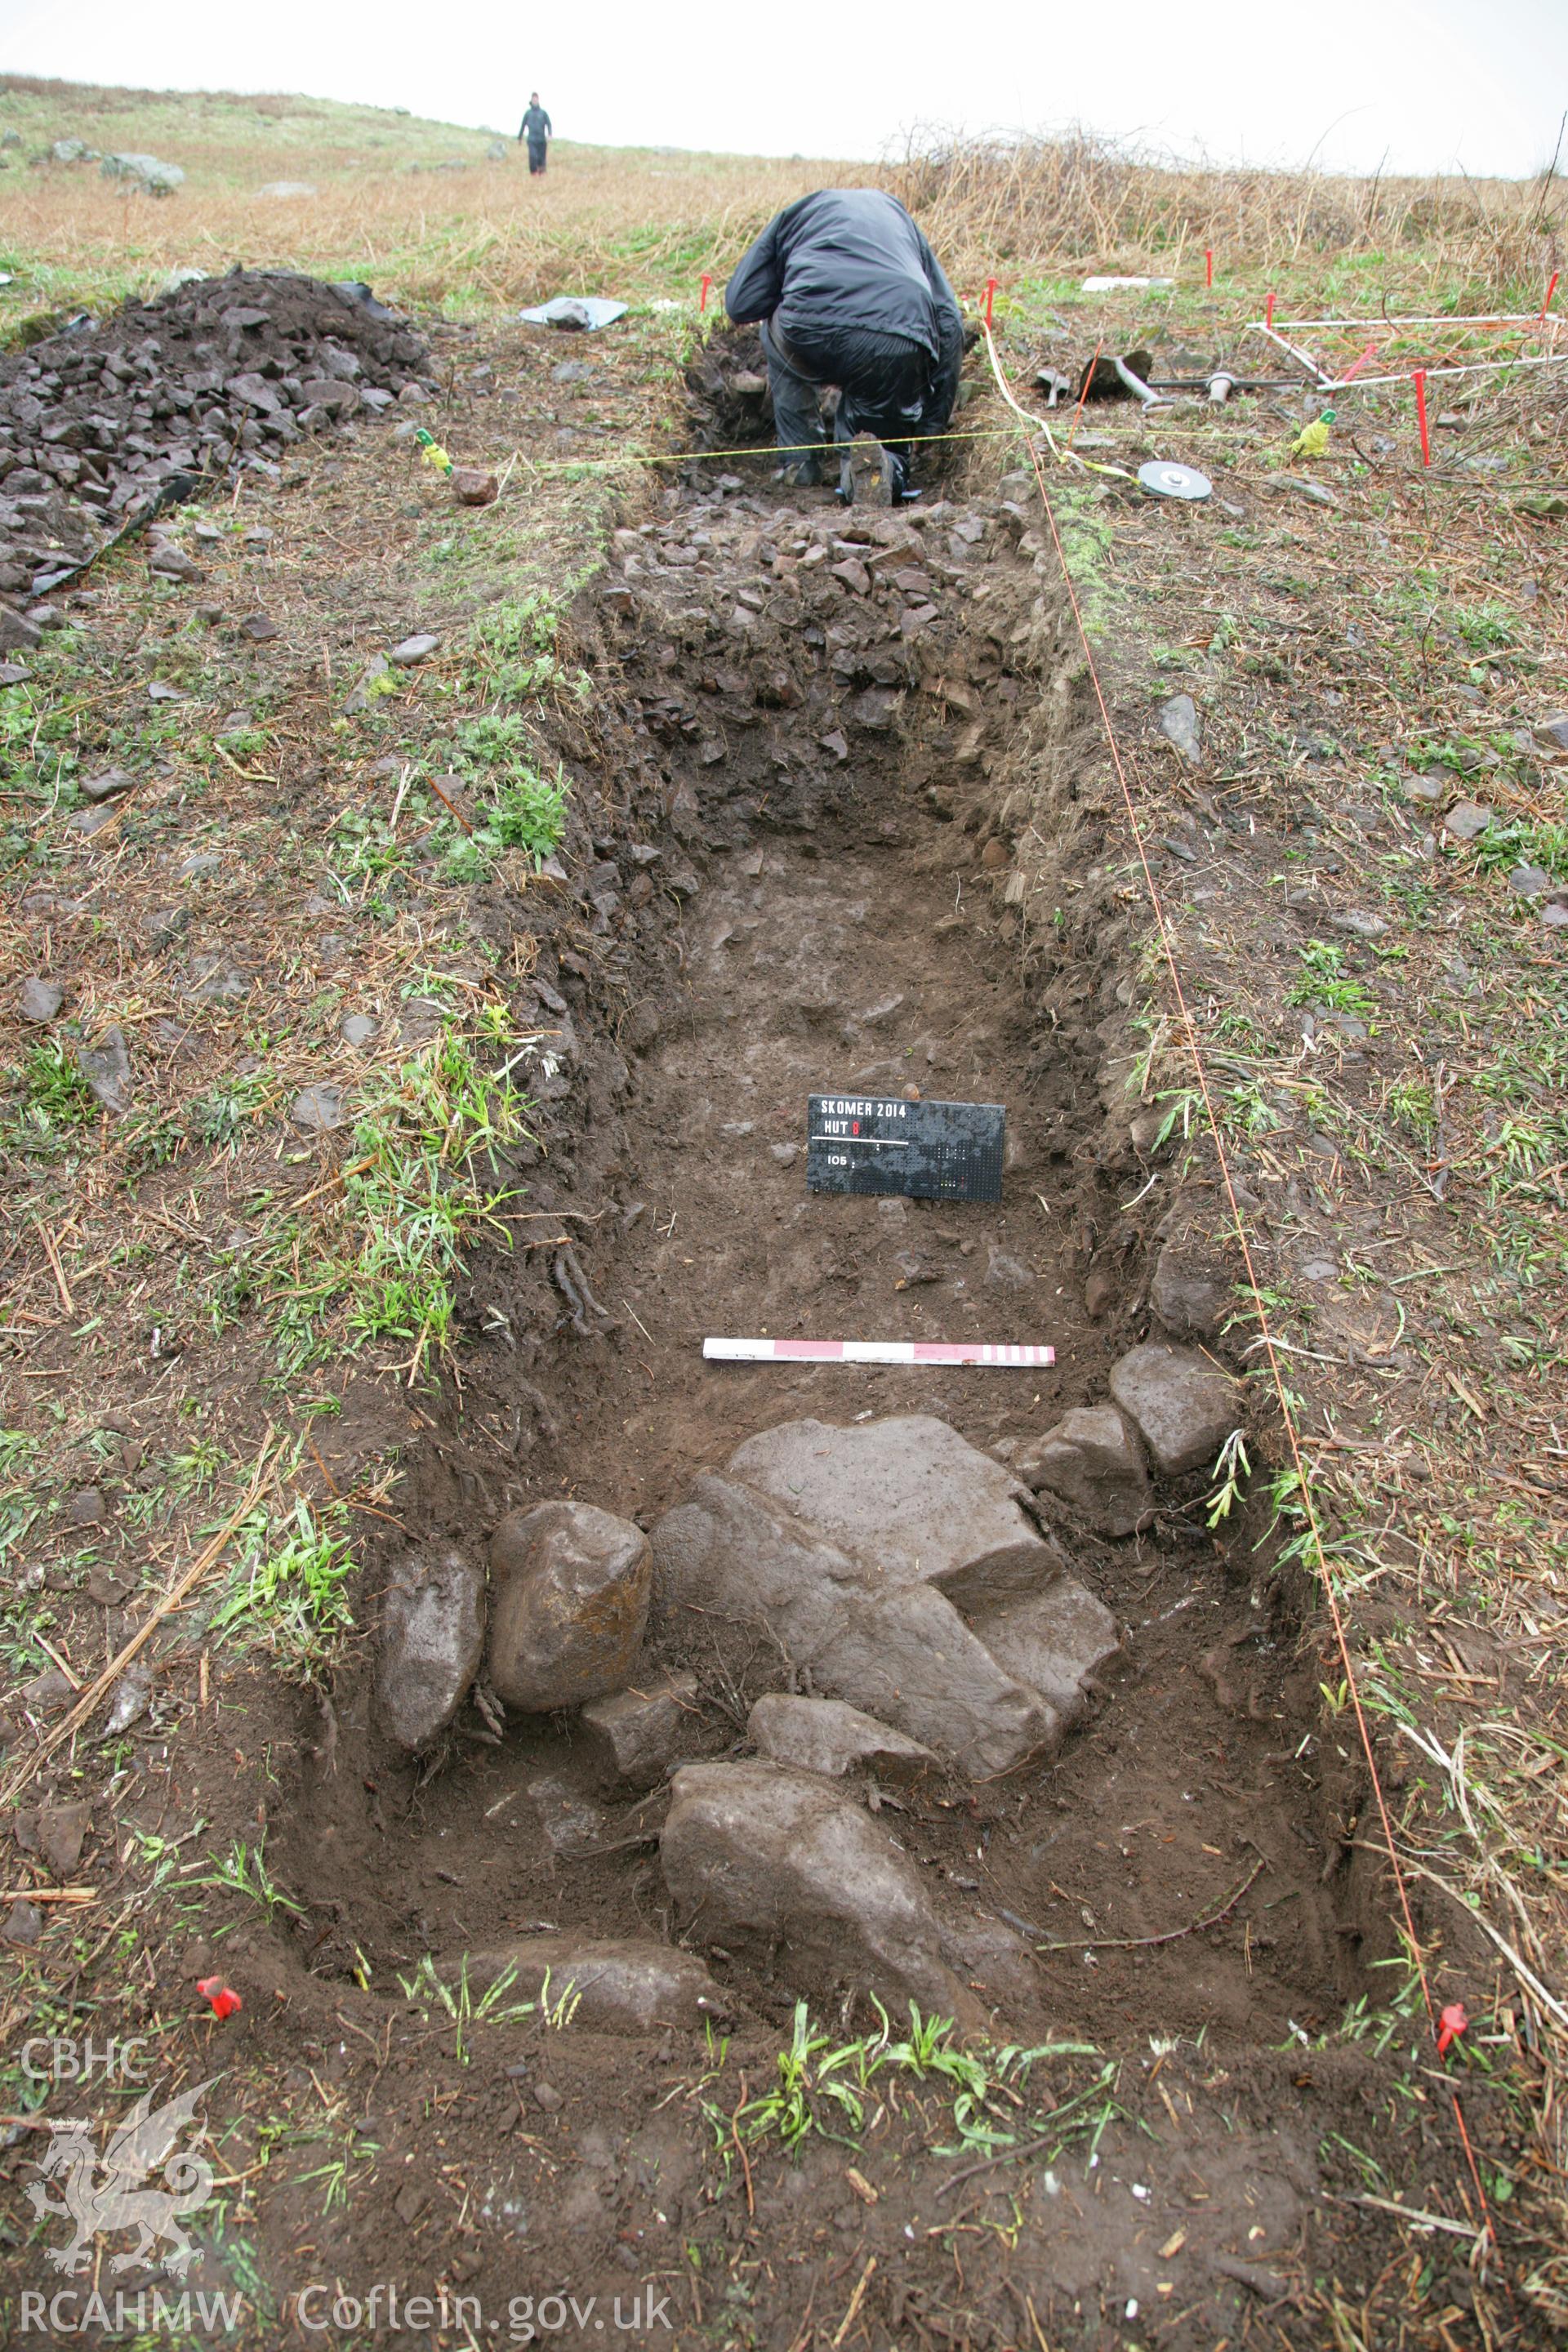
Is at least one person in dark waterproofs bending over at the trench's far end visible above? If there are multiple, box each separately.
[724,188,964,503]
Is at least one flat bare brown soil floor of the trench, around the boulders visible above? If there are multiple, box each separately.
[287,762,1347,2042]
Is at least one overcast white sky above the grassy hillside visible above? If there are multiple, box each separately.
[0,0,1568,176]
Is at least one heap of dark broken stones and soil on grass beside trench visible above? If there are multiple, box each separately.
[0,270,428,602]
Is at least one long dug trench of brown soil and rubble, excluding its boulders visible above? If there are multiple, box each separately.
[275,449,1361,2051]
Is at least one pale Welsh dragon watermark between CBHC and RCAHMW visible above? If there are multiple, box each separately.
[29,2074,219,2277]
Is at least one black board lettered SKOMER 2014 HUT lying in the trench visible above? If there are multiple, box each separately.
[806,1094,1006,1200]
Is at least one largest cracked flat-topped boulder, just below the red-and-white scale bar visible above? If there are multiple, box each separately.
[651,1414,1116,1775]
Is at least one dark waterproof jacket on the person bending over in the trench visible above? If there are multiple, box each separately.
[724,188,964,374]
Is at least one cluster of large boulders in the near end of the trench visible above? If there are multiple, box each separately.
[378,1373,1236,2032]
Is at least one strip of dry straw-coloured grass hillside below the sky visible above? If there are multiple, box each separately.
[0,75,1568,333]
